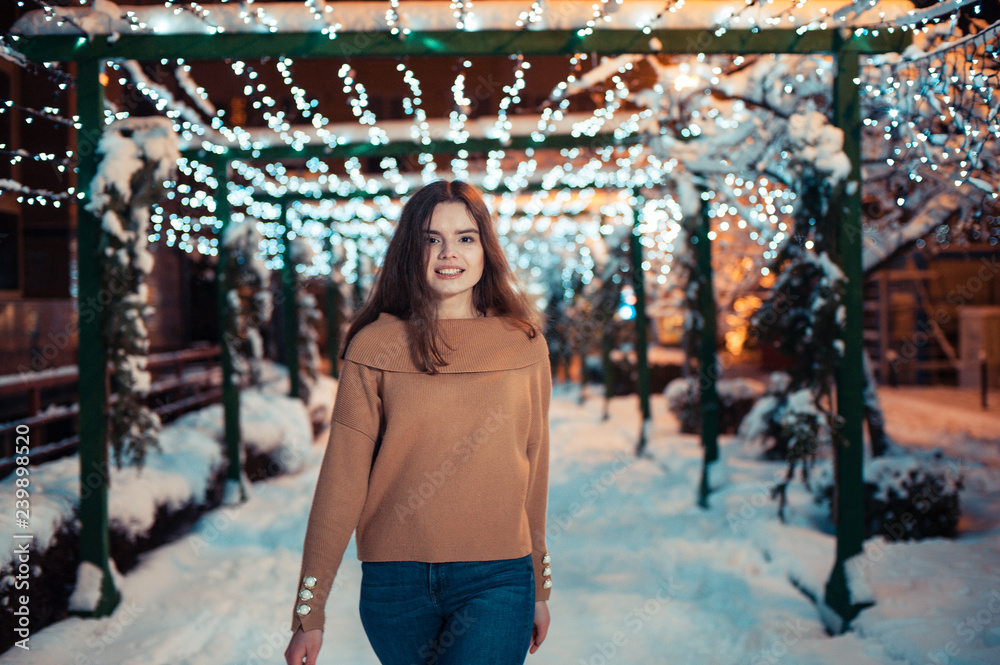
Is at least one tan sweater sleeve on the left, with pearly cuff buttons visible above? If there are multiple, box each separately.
[292,360,382,632]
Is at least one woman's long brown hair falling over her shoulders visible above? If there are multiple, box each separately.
[340,180,542,374]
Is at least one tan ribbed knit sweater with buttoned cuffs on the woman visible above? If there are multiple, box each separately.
[292,314,552,631]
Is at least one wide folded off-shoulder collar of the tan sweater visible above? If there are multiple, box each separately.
[344,312,549,374]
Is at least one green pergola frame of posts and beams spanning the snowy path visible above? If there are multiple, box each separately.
[14,22,911,625]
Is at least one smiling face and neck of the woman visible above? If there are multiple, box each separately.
[424,202,484,318]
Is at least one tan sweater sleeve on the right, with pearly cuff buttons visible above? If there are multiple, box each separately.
[525,356,552,601]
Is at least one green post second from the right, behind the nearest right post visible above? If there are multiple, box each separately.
[685,184,719,508]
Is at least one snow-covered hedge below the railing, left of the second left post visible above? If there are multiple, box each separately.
[0,423,226,650]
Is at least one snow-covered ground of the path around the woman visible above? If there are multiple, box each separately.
[0,386,1000,665]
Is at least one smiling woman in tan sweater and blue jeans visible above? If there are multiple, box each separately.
[285,181,552,665]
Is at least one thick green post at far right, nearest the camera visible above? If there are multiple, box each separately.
[826,42,865,627]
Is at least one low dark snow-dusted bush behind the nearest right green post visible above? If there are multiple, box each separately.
[813,451,963,540]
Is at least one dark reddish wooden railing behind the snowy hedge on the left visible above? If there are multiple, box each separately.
[0,346,222,478]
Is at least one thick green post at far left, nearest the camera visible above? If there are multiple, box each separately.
[73,60,121,617]
